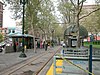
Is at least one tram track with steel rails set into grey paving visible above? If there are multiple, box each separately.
[0,49,59,75]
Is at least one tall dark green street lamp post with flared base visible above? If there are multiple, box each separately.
[19,0,28,58]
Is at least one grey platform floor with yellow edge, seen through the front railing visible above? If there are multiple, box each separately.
[46,60,88,75]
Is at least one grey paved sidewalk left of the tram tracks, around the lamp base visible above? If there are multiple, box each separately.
[0,46,60,71]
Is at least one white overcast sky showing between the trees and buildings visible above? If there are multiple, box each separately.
[0,0,95,27]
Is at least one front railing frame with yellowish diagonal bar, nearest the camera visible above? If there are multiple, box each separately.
[53,55,94,75]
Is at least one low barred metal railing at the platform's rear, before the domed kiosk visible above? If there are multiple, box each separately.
[61,48,89,57]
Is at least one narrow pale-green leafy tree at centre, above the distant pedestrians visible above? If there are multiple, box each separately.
[37,0,55,40]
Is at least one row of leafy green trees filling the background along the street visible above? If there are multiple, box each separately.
[1,0,100,47]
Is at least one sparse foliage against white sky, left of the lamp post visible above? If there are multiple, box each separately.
[3,0,22,20]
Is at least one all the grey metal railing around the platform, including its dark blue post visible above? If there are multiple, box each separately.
[54,46,100,75]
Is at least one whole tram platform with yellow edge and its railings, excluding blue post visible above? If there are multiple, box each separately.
[46,48,100,75]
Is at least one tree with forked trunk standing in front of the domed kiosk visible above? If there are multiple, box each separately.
[57,0,100,47]
